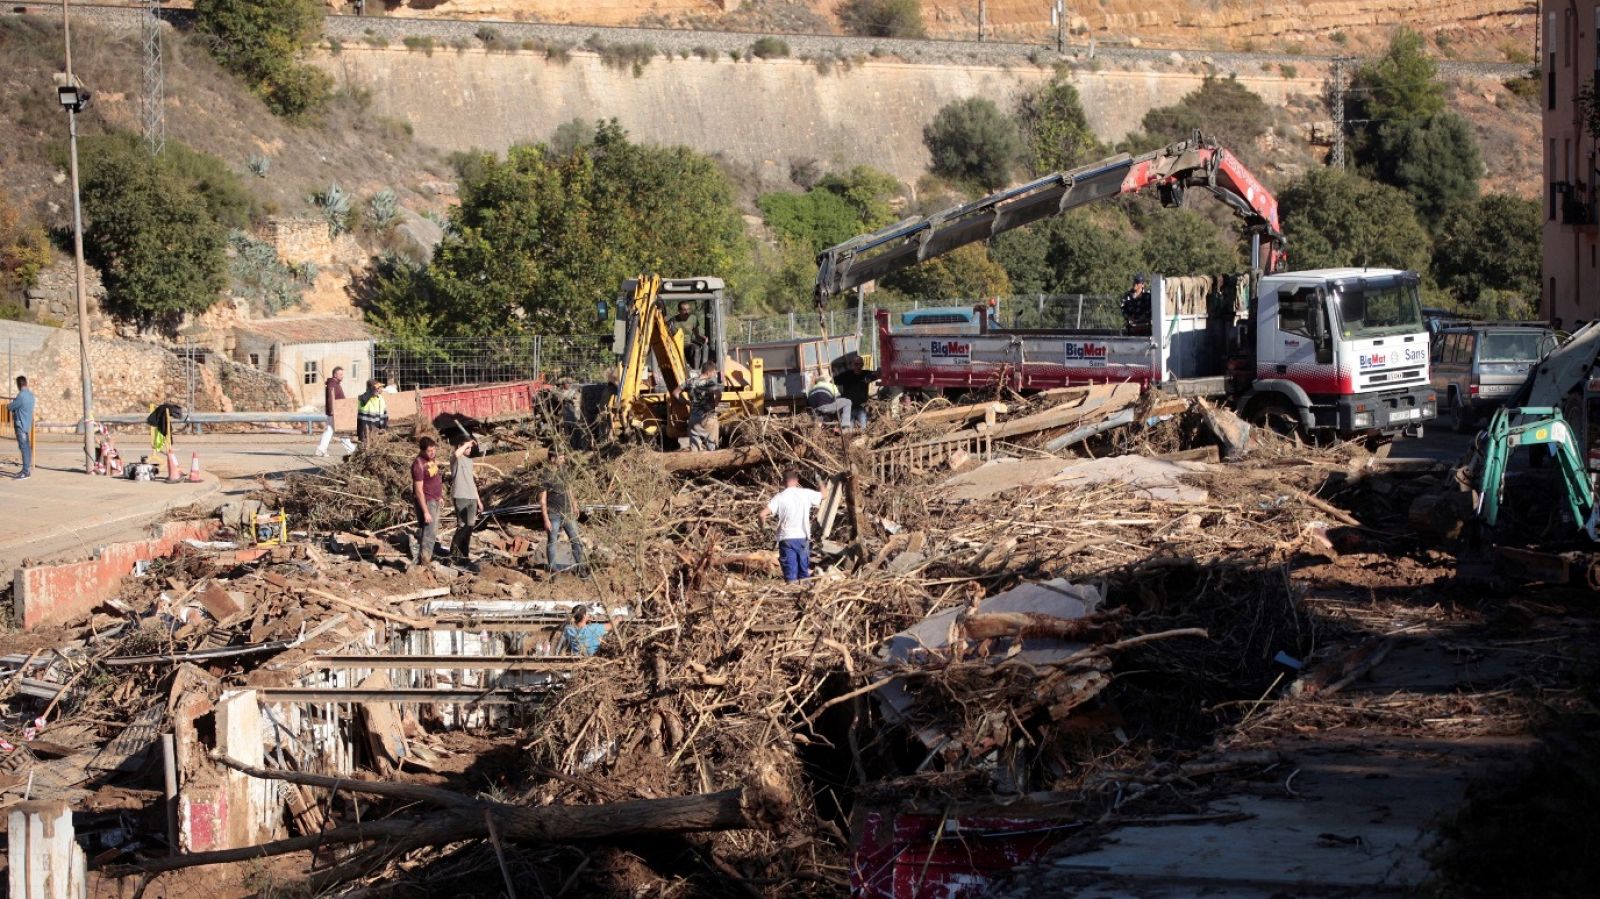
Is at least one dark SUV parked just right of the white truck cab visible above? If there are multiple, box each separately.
[1430,322,1557,432]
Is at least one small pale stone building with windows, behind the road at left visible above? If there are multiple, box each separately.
[234,315,373,408]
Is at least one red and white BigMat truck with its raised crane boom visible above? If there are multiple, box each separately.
[818,136,1437,437]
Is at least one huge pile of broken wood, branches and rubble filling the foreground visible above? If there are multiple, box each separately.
[0,387,1587,896]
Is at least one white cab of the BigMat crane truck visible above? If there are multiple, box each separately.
[1242,269,1438,435]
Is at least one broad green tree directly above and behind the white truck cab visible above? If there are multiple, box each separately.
[1278,170,1429,272]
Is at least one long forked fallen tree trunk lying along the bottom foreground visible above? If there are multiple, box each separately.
[102,753,794,877]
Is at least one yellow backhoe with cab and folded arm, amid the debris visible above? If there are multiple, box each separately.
[611,275,763,448]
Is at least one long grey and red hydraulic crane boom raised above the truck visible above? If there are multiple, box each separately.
[816,133,1285,309]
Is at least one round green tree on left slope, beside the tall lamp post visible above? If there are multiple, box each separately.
[80,134,227,330]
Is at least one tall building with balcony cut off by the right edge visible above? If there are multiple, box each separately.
[1539,0,1600,321]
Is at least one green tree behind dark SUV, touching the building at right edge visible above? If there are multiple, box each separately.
[1434,194,1542,312]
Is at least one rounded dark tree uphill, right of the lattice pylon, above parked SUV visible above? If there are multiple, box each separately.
[1376,112,1483,226]
